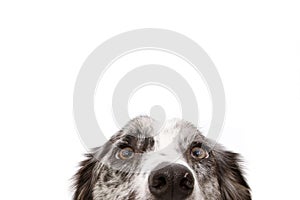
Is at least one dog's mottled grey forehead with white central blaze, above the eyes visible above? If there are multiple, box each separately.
[112,116,201,150]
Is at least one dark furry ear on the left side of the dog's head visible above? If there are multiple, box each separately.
[73,154,97,200]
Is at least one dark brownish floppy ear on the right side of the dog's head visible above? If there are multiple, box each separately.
[216,150,251,200]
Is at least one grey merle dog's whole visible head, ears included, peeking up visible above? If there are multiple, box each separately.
[74,117,251,200]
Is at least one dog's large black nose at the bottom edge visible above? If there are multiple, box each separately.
[148,163,194,200]
